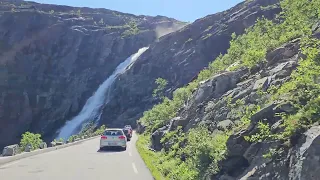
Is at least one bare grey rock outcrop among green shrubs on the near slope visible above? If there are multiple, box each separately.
[146,25,320,180]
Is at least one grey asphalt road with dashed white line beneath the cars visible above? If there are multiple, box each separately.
[0,131,153,180]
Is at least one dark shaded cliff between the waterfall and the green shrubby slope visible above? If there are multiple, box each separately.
[102,0,281,126]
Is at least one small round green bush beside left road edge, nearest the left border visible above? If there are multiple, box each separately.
[20,132,43,151]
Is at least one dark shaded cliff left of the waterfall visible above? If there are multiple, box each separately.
[0,0,184,147]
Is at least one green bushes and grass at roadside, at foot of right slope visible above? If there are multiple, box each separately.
[137,126,229,180]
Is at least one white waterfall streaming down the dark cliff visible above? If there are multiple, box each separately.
[57,47,149,139]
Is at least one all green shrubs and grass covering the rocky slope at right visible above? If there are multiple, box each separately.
[138,0,320,180]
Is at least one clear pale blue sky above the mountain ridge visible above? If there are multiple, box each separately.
[31,0,243,22]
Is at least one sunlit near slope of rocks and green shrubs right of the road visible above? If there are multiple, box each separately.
[138,0,320,180]
